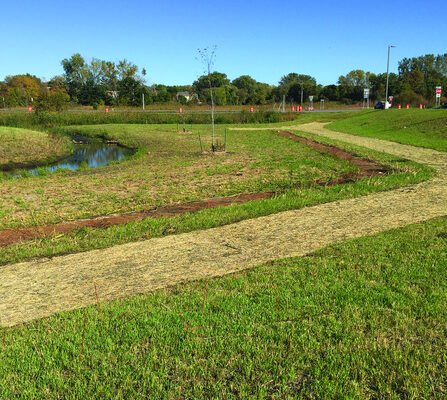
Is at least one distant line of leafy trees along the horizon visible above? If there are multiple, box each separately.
[0,54,447,110]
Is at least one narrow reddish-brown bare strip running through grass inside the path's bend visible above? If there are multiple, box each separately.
[0,130,389,247]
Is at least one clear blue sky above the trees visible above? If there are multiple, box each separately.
[0,0,447,85]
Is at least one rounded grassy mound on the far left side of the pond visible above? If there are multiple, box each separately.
[0,126,72,169]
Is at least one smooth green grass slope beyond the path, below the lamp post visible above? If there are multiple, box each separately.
[328,109,447,151]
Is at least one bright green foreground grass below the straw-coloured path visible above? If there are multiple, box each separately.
[0,218,447,399]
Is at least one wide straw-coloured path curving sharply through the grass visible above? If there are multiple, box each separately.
[0,123,447,326]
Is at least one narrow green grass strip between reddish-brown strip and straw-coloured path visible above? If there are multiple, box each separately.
[0,129,433,265]
